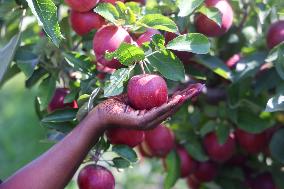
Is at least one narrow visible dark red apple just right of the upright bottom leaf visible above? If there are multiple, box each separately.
[177,147,198,178]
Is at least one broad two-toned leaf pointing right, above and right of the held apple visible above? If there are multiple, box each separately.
[167,33,210,54]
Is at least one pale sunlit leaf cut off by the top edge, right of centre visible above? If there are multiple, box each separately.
[178,0,204,17]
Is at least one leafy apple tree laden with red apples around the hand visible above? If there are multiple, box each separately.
[0,0,284,189]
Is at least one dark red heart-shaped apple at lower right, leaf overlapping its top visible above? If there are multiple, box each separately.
[203,132,236,163]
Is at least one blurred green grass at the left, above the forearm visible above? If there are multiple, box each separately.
[0,75,51,179]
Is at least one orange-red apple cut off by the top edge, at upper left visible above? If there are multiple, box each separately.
[65,0,99,12]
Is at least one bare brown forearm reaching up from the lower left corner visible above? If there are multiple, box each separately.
[0,113,103,189]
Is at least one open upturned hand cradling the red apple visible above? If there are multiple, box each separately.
[91,83,204,130]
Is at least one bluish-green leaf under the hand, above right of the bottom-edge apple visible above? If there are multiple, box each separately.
[112,145,138,163]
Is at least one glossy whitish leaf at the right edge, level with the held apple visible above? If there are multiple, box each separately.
[265,93,284,112]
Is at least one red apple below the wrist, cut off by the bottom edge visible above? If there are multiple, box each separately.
[78,165,115,189]
